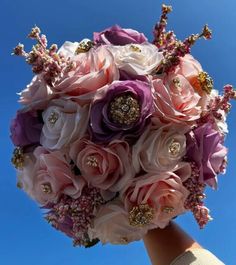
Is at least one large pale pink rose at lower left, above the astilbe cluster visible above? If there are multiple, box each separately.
[19,147,85,205]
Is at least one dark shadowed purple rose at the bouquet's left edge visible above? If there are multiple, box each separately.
[10,111,43,147]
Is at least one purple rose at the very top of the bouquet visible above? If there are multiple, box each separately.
[93,25,147,45]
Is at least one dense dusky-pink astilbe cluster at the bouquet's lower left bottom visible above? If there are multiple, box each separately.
[43,186,104,247]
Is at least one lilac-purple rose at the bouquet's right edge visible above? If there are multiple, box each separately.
[186,123,227,189]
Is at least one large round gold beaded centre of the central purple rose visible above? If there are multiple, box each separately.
[110,94,140,125]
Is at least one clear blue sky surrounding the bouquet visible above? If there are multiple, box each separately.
[0,0,236,265]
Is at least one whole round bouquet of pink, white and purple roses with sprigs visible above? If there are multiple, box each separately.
[11,5,236,247]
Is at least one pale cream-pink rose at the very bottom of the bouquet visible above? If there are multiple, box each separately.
[88,199,155,244]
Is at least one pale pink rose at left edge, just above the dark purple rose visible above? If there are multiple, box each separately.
[19,75,53,109]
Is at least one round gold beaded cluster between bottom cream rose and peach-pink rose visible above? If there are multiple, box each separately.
[129,203,154,227]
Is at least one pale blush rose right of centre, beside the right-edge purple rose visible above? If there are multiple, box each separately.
[132,118,189,173]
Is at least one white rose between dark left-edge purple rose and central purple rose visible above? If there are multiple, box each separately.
[40,99,89,149]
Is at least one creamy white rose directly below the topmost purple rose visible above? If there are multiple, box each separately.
[108,43,163,75]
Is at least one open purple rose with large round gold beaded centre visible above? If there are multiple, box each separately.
[90,80,154,143]
